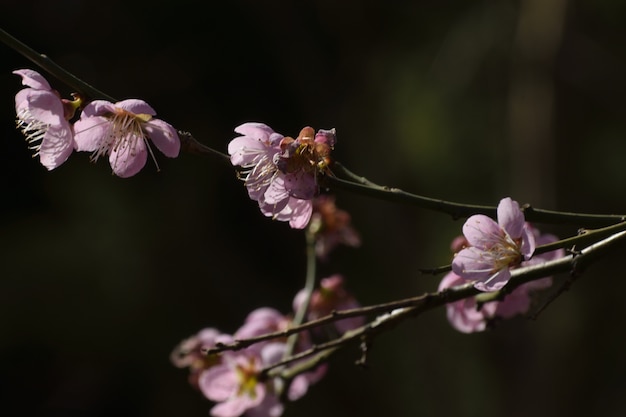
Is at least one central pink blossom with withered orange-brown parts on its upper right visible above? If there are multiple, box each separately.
[228,122,336,229]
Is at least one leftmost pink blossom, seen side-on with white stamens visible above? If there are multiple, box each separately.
[13,69,81,170]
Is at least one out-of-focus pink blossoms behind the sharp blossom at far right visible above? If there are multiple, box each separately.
[439,223,565,333]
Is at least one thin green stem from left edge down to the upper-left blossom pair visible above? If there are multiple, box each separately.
[0,28,117,102]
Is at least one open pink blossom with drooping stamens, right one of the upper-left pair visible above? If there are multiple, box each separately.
[74,99,180,178]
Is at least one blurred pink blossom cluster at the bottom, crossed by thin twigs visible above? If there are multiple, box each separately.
[171,275,363,417]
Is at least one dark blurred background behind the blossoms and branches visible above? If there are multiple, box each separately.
[0,0,626,417]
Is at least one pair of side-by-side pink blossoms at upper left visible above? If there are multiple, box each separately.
[13,69,180,177]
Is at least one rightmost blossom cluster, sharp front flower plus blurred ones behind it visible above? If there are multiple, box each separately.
[439,197,565,333]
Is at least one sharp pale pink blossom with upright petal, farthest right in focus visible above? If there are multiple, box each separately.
[452,197,535,291]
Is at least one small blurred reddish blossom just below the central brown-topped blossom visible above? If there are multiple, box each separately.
[309,195,361,260]
